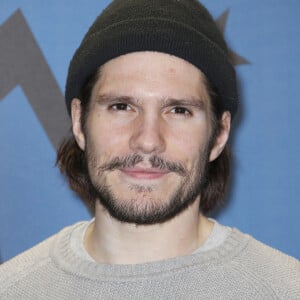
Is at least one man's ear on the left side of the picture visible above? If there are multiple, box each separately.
[71,98,85,150]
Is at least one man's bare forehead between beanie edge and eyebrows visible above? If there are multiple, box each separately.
[93,51,209,102]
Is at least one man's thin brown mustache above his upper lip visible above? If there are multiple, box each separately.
[98,154,187,176]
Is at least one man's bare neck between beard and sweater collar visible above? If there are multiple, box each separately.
[84,199,213,264]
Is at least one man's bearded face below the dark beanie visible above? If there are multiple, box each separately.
[72,52,218,224]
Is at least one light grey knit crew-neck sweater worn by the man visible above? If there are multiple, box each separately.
[0,223,300,300]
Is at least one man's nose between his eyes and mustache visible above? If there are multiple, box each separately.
[129,114,166,154]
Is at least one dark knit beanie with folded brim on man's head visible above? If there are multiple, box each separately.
[65,0,238,118]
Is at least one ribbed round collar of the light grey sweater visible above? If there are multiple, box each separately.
[51,223,249,282]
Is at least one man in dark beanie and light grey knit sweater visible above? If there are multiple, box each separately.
[0,0,300,299]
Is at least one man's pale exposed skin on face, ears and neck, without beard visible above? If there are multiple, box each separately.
[71,52,230,264]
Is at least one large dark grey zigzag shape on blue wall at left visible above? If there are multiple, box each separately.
[0,10,70,148]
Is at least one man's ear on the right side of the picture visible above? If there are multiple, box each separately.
[209,111,231,161]
